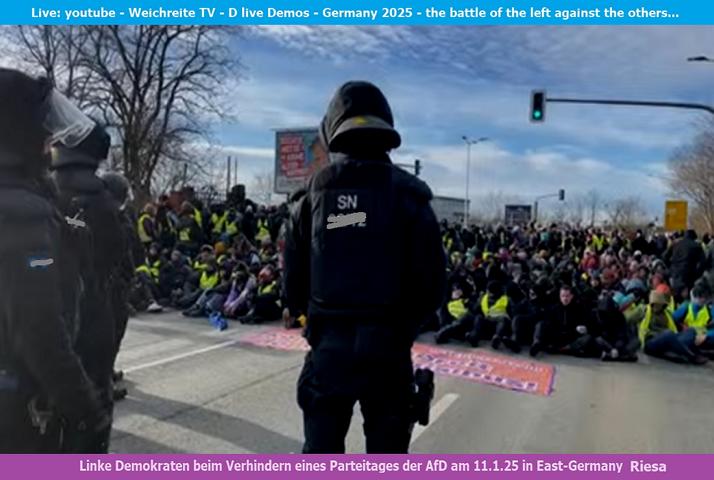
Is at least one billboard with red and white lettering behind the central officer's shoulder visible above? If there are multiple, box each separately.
[274,128,329,194]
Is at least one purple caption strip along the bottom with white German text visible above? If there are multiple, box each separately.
[0,455,700,480]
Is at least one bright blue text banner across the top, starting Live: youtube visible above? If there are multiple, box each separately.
[22,0,714,25]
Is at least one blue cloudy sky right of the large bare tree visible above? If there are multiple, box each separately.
[216,26,714,215]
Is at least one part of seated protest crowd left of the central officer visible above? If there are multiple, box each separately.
[130,189,294,323]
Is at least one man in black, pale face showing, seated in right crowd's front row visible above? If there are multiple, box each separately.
[530,285,599,357]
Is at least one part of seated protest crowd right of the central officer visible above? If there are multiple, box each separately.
[432,222,714,364]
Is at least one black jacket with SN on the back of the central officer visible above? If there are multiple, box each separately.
[285,154,446,344]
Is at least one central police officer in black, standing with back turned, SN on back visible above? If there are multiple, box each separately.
[285,82,446,453]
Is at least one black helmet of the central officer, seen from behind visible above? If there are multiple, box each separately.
[320,81,402,152]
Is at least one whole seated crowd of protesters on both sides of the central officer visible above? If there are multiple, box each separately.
[131,188,714,364]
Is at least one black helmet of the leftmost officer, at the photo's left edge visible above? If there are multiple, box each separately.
[0,68,52,167]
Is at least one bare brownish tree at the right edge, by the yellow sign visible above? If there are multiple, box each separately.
[668,121,714,232]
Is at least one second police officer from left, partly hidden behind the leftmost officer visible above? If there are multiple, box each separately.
[51,122,129,453]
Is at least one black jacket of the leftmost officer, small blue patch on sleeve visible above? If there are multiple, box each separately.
[0,173,99,421]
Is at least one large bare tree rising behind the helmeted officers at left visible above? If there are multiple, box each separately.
[6,25,240,195]
